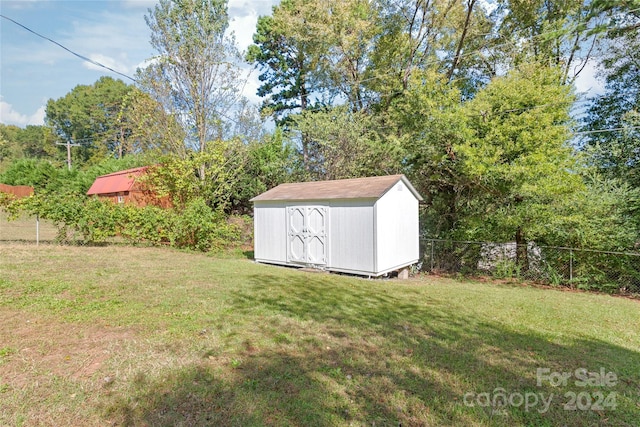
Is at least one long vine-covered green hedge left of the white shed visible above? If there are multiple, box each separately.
[0,194,240,252]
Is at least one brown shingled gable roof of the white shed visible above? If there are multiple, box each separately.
[251,175,422,202]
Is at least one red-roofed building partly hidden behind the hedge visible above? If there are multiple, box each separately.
[87,166,170,207]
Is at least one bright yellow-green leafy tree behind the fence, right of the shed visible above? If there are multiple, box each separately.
[456,63,583,261]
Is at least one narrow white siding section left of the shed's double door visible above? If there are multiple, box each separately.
[253,203,287,264]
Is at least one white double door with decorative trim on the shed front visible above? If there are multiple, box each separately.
[287,206,327,265]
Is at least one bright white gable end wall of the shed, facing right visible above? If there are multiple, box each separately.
[375,181,419,273]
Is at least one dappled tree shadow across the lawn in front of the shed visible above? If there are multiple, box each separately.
[108,274,640,426]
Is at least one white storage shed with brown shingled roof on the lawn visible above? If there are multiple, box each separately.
[251,175,422,276]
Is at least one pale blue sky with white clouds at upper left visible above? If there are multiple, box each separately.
[0,0,278,127]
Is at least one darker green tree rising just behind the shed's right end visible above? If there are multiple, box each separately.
[384,70,470,237]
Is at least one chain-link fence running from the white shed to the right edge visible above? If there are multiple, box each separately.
[420,239,640,293]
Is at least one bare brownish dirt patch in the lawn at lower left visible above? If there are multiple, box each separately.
[0,309,135,389]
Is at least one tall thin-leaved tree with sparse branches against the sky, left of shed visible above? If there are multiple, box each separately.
[139,0,241,154]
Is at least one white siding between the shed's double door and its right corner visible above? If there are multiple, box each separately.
[327,200,375,274]
